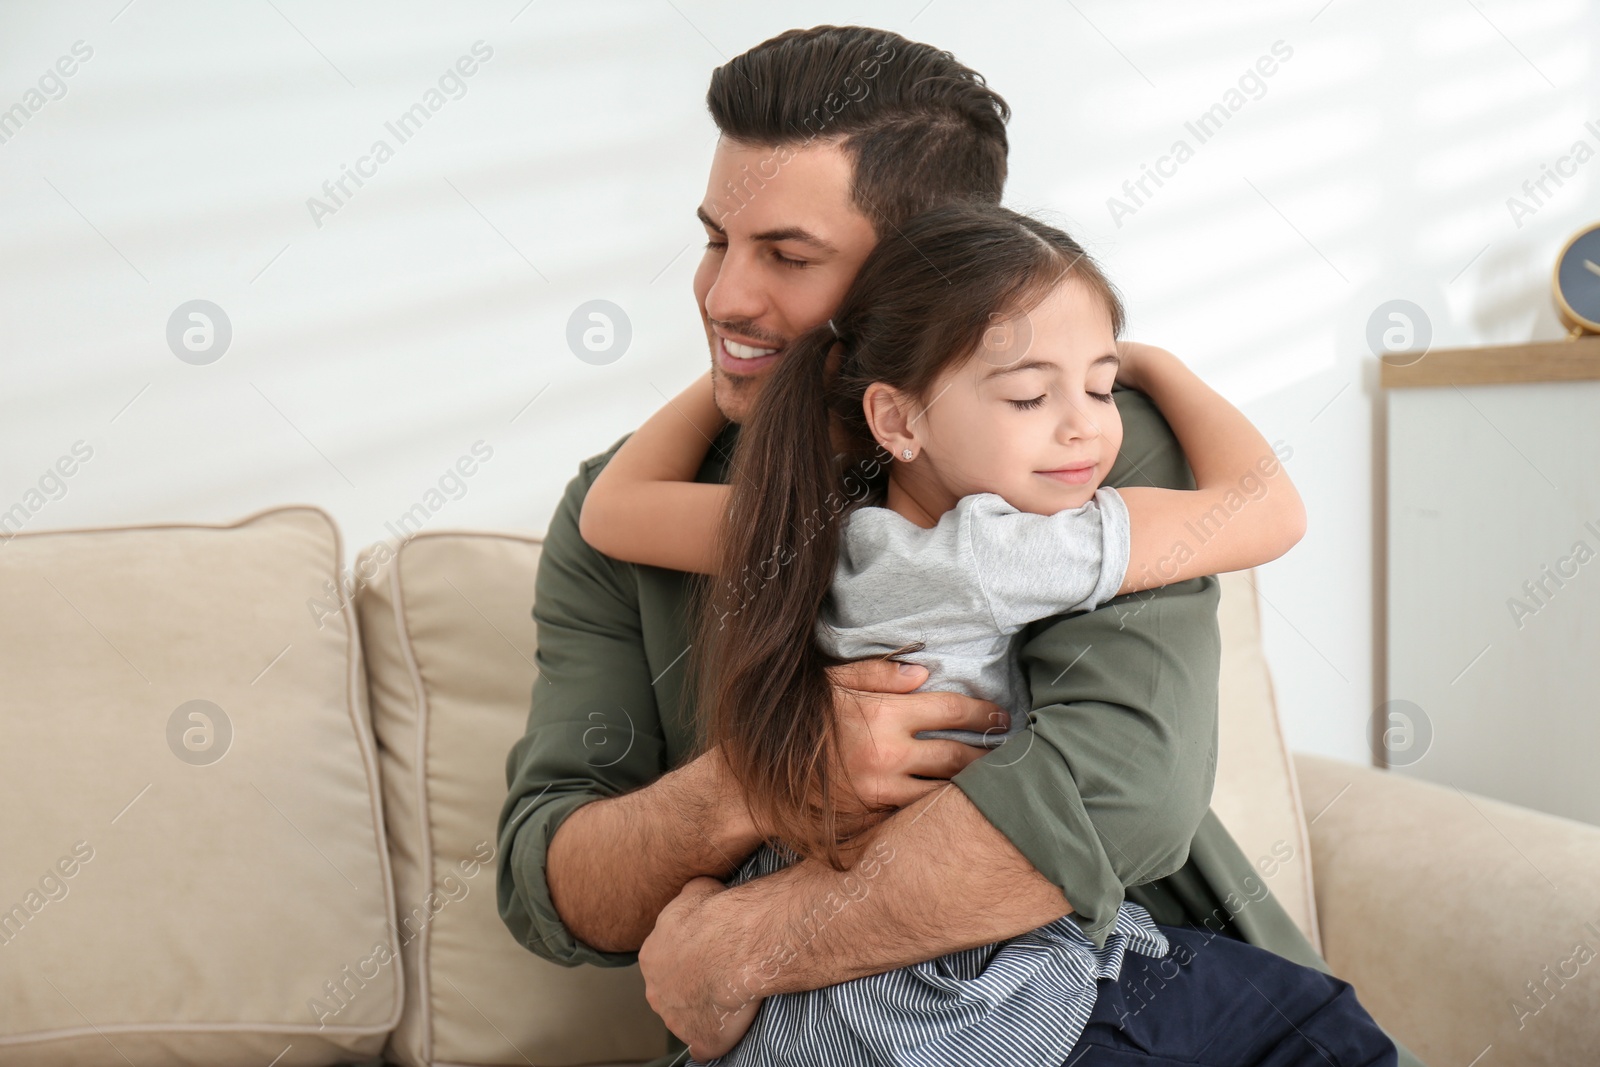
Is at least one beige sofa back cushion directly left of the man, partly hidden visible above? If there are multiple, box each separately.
[355,531,667,1067]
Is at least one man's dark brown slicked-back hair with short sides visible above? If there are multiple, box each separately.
[706,26,1011,238]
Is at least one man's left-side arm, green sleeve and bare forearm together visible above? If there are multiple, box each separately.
[498,448,758,966]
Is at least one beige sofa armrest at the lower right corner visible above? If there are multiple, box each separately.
[1294,753,1600,1067]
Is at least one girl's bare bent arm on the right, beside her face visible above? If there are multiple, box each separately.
[1117,342,1306,595]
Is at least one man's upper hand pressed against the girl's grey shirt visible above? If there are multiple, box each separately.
[829,659,1010,825]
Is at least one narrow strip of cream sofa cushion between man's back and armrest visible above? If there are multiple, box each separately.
[1211,571,1322,952]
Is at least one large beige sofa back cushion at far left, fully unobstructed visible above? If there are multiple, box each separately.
[0,507,402,1067]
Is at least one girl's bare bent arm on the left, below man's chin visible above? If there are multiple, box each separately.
[578,371,730,574]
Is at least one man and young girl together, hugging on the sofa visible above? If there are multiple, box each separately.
[499,26,1419,1067]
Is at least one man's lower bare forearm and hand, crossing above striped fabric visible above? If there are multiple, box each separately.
[638,784,1070,1059]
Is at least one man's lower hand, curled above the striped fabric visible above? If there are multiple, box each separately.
[638,878,762,1061]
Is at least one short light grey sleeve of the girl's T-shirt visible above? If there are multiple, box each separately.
[962,486,1130,633]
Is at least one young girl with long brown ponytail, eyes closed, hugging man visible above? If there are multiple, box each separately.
[579,205,1392,1065]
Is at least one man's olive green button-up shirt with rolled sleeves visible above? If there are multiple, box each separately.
[498,389,1418,1064]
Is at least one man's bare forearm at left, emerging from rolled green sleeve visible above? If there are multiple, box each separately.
[546,750,760,952]
